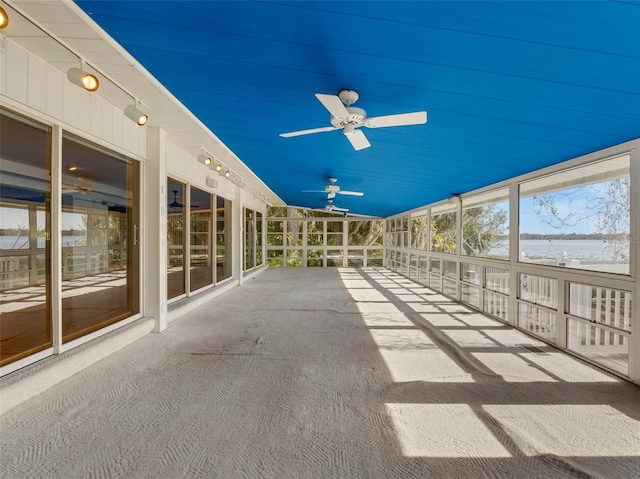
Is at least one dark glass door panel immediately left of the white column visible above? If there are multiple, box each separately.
[61,133,139,342]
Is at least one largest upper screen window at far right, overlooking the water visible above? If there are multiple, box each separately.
[519,155,631,274]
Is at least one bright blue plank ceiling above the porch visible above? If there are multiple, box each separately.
[77,0,640,216]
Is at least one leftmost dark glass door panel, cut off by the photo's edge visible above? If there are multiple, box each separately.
[0,110,52,366]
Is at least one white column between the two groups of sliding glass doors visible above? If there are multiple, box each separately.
[146,127,167,333]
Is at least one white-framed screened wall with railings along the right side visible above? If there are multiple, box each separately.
[385,150,638,376]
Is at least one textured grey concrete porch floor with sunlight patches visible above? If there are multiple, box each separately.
[0,268,640,479]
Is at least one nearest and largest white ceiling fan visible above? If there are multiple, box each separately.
[280,90,427,150]
